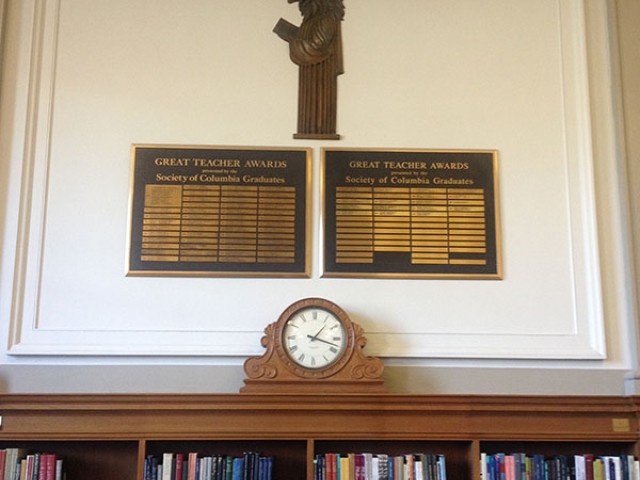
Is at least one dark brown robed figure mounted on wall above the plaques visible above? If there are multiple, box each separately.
[273,0,344,139]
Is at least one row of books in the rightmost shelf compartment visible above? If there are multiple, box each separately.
[480,453,640,480]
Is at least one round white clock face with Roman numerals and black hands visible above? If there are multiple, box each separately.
[282,306,347,370]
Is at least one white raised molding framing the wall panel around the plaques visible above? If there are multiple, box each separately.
[3,0,614,359]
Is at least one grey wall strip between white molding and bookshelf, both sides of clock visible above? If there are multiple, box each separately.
[0,366,627,395]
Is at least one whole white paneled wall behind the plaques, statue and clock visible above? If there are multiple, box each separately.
[0,0,637,394]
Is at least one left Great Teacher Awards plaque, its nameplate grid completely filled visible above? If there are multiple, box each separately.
[127,145,311,277]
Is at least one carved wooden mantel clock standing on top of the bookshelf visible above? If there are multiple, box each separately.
[240,298,387,393]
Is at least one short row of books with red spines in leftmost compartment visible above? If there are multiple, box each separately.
[0,447,65,480]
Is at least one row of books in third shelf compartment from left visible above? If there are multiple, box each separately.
[314,453,447,480]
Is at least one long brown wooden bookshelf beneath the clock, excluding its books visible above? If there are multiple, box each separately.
[0,394,640,480]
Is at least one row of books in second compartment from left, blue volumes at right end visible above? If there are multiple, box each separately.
[144,452,273,480]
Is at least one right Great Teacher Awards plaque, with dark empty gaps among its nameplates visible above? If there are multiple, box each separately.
[322,148,501,279]
